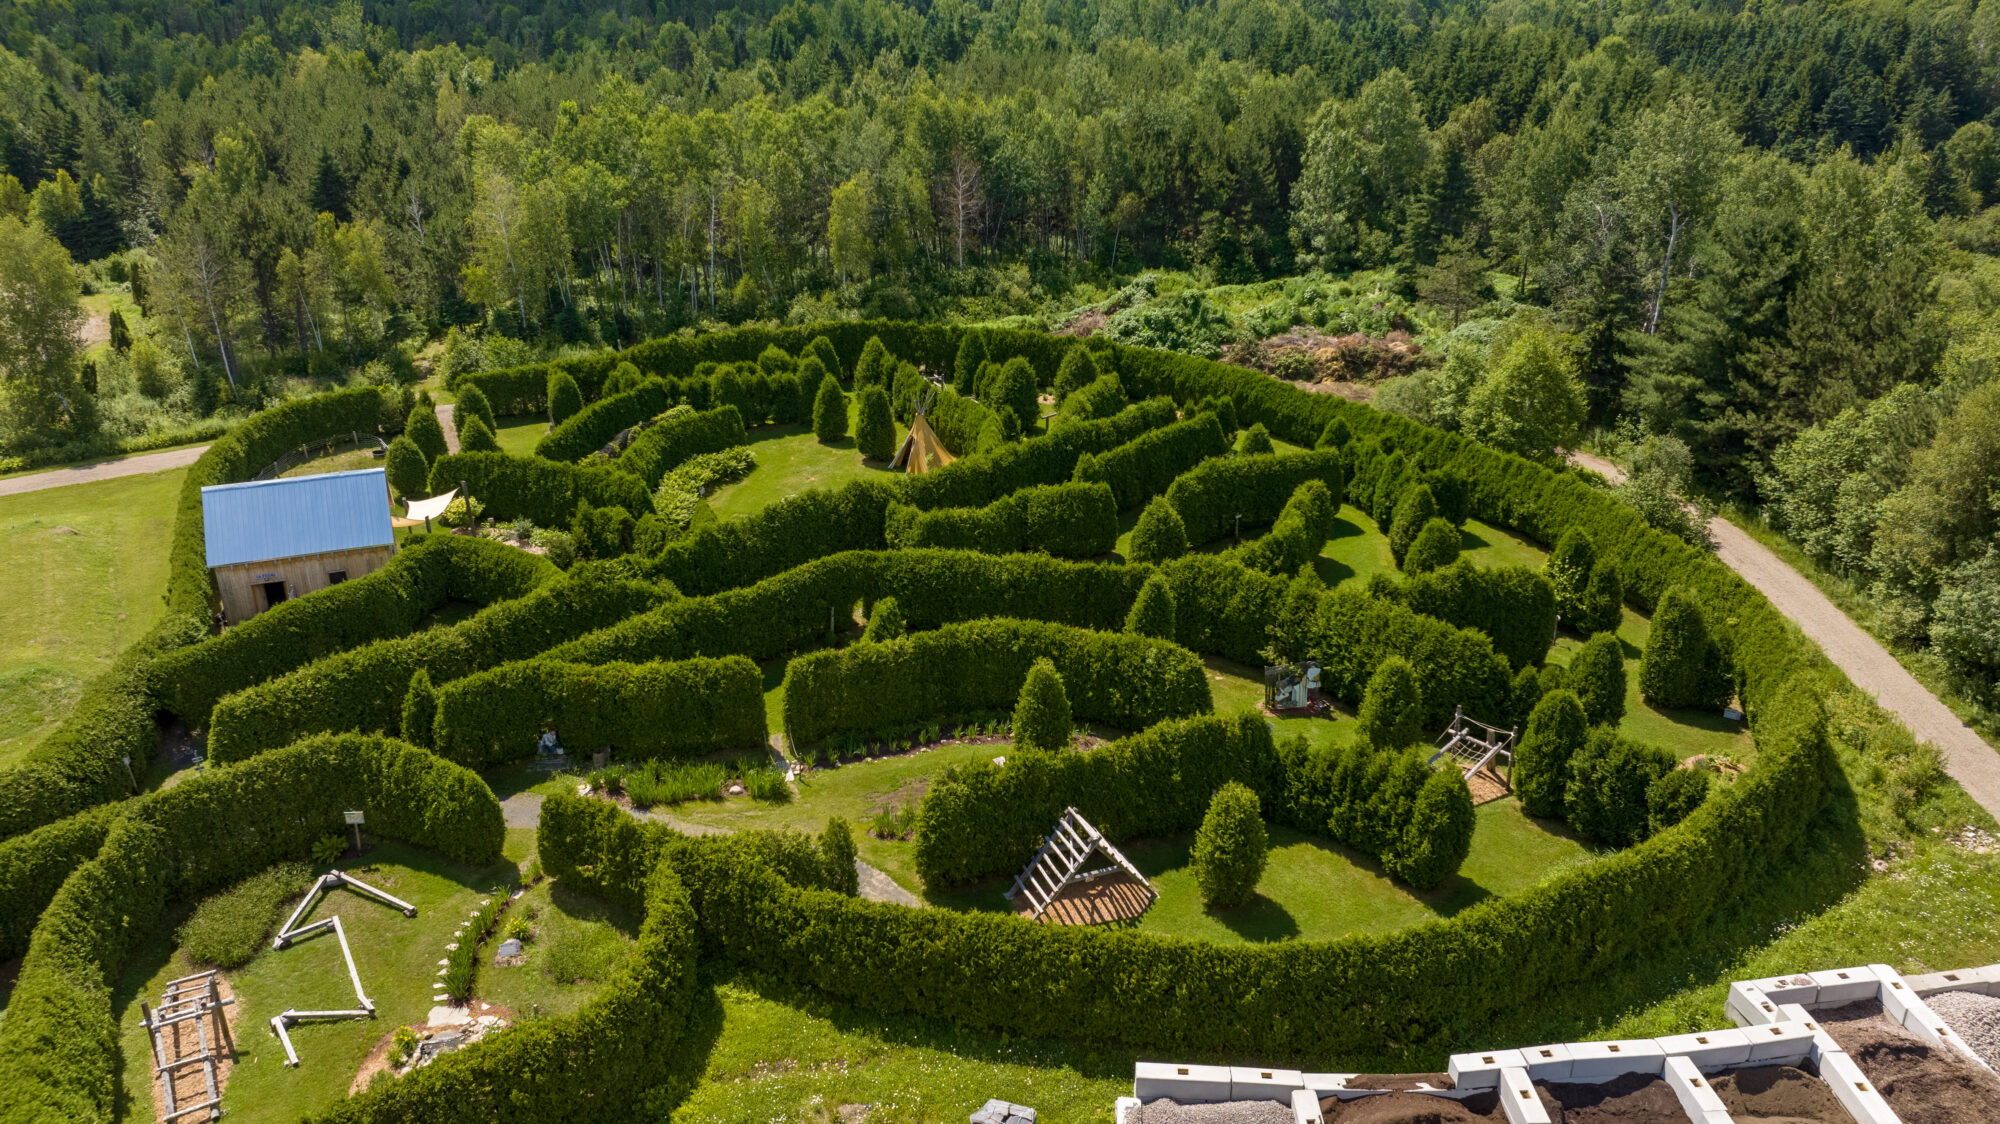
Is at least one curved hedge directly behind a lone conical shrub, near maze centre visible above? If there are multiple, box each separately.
[784,612,1212,742]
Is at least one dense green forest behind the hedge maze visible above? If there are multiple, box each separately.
[11,0,2000,706]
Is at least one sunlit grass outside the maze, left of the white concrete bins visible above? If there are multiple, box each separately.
[674,980,1134,1124]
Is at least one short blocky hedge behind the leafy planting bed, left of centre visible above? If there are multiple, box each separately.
[430,656,768,768]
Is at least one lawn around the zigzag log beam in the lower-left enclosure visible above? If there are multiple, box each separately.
[112,842,516,1122]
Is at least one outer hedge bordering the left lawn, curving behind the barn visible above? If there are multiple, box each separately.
[0,388,400,838]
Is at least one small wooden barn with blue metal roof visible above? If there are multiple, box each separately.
[202,468,396,624]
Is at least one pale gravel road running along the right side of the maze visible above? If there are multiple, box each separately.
[1570,452,2000,816]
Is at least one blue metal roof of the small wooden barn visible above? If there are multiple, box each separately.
[202,468,396,568]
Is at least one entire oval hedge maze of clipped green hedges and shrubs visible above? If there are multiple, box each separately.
[0,322,1840,1122]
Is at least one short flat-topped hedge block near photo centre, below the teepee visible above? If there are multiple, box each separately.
[884,482,1118,558]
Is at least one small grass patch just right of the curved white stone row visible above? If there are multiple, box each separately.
[474,880,640,1018]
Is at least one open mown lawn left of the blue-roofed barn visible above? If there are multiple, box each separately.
[0,468,186,768]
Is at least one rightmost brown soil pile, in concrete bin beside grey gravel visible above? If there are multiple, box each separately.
[1812,1000,2000,1124]
